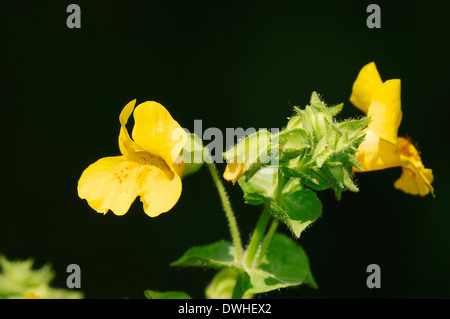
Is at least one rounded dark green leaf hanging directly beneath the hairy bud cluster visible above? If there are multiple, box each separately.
[265,189,322,238]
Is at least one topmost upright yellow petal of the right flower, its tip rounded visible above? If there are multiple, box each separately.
[350,62,383,114]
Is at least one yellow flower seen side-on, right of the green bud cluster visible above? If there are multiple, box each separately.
[350,62,434,196]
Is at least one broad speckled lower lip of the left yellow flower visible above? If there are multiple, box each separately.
[78,153,181,217]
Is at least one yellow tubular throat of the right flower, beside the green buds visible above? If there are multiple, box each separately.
[355,128,401,172]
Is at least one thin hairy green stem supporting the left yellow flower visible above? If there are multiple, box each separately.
[205,151,242,262]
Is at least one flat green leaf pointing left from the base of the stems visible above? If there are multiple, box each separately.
[170,240,238,268]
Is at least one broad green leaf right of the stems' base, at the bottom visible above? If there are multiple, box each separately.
[246,233,317,294]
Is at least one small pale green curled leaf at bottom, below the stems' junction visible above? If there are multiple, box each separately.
[205,267,239,299]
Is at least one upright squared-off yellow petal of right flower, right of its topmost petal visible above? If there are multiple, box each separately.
[367,79,402,144]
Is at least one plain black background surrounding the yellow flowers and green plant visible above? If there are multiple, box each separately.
[0,1,450,298]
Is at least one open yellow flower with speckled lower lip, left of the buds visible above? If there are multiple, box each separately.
[78,100,187,217]
